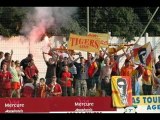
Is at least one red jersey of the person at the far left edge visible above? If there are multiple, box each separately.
[0,71,12,89]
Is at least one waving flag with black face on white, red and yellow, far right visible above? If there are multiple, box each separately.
[133,42,153,70]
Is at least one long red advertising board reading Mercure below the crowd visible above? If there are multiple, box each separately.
[0,97,116,113]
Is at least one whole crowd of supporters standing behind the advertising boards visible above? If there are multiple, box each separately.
[0,44,160,98]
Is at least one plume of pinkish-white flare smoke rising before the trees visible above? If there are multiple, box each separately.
[21,7,77,53]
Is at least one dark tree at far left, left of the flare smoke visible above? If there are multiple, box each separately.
[0,7,27,37]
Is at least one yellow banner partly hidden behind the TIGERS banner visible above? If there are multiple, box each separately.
[88,32,110,47]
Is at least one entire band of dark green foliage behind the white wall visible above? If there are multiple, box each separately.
[0,7,160,42]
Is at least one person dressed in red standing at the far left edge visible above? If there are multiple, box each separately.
[0,63,12,97]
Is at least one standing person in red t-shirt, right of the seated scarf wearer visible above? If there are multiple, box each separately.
[61,65,73,96]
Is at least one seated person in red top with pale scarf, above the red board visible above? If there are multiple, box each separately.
[48,76,62,97]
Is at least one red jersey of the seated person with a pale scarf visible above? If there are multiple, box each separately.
[48,83,62,96]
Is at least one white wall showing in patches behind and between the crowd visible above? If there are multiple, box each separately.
[0,36,160,82]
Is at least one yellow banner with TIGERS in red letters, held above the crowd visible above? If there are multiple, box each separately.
[68,34,100,53]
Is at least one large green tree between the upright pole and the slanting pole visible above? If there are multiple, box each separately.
[90,7,143,42]
